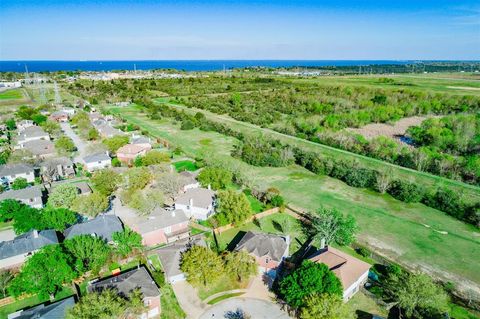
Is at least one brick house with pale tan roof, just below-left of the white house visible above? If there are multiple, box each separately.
[126,208,190,246]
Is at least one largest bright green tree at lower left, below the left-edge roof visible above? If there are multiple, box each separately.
[8,245,76,299]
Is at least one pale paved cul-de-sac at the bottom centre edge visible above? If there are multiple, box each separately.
[199,297,290,319]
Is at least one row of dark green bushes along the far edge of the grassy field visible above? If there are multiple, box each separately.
[233,138,480,227]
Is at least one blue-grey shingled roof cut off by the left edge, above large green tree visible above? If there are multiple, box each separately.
[0,229,58,259]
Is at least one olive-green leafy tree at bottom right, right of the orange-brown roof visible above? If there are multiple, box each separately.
[387,273,448,318]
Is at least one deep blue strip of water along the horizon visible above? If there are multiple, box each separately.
[0,60,412,72]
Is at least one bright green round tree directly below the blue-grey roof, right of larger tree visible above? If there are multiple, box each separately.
[64,235,110,273]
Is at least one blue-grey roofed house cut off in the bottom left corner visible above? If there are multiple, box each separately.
[7,296,75,319]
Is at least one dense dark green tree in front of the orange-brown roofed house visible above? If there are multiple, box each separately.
[279,260,342,308]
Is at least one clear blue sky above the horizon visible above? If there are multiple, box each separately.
[0,0,480,60]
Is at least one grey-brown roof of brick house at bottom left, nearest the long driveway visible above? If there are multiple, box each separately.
[88,266,160,298]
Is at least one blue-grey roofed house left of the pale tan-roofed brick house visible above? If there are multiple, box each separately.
[63,214,123,243]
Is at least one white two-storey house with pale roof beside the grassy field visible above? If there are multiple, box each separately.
[175,188,215,220]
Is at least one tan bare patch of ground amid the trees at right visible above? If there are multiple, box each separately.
[347,116,432,139]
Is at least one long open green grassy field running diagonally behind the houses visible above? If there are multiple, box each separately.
[110,107,480,296]
